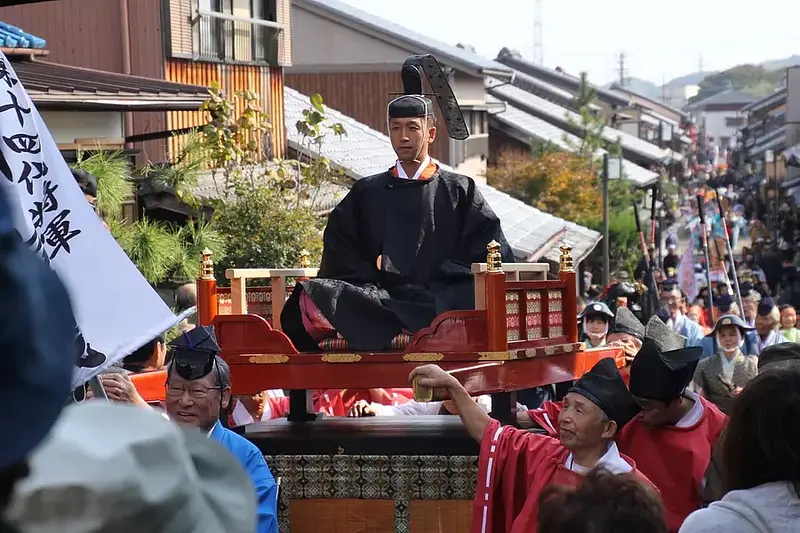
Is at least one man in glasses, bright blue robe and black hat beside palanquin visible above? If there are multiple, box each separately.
[166,326,278,533]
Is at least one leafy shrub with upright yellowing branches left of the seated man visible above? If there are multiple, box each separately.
[201,87,347,283]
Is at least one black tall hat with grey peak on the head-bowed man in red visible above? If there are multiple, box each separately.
[630,316,703,402]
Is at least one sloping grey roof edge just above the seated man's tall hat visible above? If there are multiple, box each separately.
[293,0,511,77]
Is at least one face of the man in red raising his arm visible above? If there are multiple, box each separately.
[558,392,617,451]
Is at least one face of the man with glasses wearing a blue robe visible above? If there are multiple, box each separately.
[167,369,231,431]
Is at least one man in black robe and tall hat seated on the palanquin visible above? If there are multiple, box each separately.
[281,56,513,351]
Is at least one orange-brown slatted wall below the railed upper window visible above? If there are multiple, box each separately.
[166,59,286,157]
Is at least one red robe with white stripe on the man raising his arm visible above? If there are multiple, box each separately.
[472,420,655,533]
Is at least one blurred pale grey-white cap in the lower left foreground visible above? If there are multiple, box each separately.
[8,401,256,533]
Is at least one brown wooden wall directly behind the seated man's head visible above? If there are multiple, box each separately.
[284,71,450,162]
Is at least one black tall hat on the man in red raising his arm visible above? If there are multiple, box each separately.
[569,357,640,430]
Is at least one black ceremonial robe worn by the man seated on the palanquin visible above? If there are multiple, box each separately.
[281,170,514,351]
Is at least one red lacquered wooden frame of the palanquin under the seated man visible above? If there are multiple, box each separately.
[133,245,625,399]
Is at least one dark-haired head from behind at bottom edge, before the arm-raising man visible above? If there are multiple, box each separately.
[536,469,667,533]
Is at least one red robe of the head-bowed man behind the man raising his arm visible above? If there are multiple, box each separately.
[528,397,728,533]
